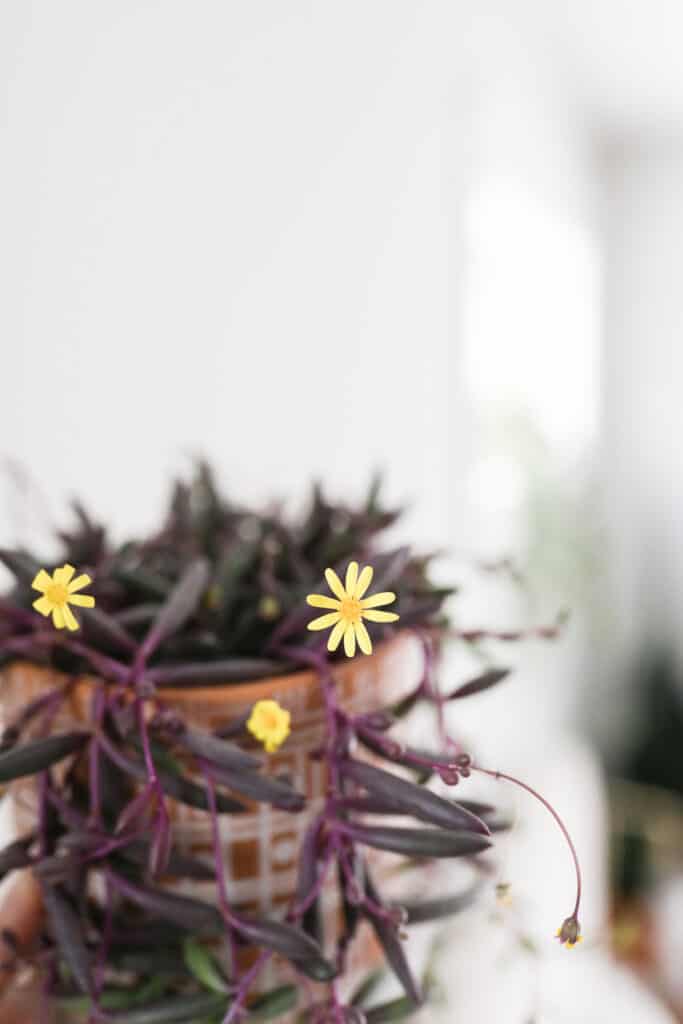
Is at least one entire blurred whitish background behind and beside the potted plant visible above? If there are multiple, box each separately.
[0,0,683,1024]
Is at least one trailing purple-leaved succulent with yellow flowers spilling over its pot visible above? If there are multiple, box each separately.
[0,466,581,1024]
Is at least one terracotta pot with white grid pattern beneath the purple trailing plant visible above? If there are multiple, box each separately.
[0,633,423,999]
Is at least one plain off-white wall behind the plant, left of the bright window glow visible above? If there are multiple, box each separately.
[0,0,452,543]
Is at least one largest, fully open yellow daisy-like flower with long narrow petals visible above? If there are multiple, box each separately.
[306,562,398,657]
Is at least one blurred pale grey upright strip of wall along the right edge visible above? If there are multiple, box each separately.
[602,135,683,745]
